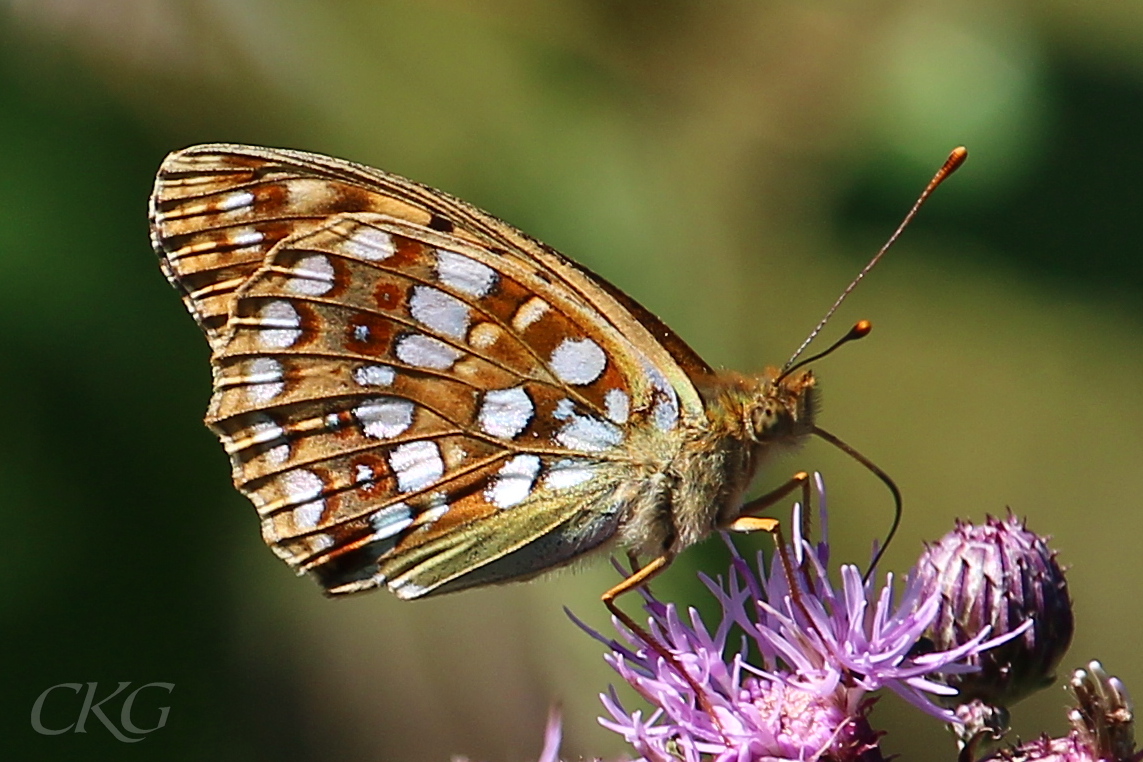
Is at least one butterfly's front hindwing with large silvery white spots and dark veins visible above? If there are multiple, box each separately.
[208,214,694,594]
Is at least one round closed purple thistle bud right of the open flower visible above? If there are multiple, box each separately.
[917,512,1073,707]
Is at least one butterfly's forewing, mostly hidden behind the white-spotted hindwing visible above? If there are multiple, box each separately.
[151,143,713,377]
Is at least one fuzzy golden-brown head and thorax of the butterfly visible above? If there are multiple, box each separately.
[624,368,816,555]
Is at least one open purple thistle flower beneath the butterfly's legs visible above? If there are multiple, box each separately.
[573,476,1012,762]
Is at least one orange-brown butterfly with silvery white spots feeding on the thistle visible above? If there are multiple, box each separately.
[150,144,962,610]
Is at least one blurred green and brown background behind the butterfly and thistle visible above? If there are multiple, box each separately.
[0,0,1143,762]
